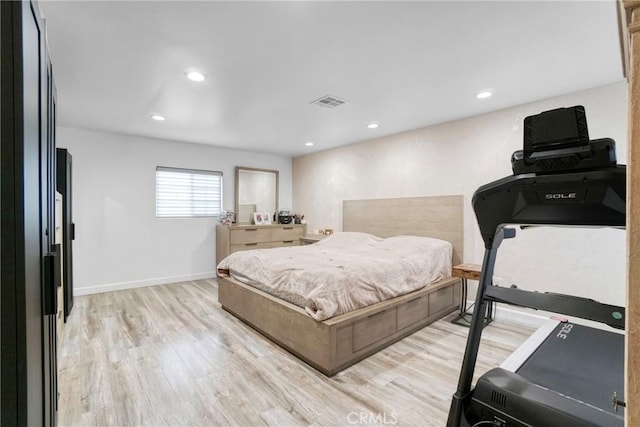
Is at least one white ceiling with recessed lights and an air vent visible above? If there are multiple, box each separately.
[41,0,623,156]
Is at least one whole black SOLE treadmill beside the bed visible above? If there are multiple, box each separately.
[447,106,626,427]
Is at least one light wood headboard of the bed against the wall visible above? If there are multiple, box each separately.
[342,195,464,265]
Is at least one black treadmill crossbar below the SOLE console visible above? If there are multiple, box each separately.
[485,285,625,329]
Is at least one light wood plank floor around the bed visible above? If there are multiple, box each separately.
[58,280,533,426]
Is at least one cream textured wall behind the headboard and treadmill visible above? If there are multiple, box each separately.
[293,82,627,305]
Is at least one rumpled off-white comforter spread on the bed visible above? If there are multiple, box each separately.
[218,233,453,320]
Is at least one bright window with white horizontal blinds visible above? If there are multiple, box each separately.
[156,166,222,218]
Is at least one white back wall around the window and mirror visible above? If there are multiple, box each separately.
[57,127,292,295]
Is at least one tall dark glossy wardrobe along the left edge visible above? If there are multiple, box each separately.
[0,0,59,426]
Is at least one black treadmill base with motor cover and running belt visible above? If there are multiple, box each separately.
[468,323,624,427]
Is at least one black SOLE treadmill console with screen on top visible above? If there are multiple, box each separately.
[472,106,627,248]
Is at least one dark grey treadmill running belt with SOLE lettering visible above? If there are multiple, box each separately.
[516,323,624,417]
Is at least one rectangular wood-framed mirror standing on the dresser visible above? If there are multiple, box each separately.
[235,166,278,224]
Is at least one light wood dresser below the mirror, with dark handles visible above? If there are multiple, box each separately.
[216,224,307,265]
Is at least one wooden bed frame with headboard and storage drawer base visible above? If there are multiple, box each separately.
[218,196,463,376]
